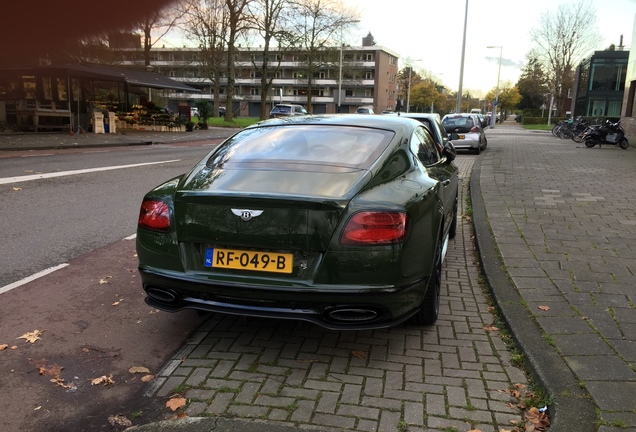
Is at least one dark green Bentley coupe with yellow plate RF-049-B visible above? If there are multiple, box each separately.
[137,115,458,330]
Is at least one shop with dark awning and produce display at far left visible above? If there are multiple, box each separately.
[0,64,199,132]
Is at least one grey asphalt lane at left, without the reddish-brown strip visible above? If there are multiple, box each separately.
[0,143,212,287]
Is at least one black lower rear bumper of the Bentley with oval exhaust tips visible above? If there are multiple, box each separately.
[139,268,427,330]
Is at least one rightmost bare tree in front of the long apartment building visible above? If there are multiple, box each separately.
[291,0,358,112]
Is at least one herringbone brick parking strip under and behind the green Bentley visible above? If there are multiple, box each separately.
[139,155,527,432]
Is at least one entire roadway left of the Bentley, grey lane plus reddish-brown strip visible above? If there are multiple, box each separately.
[0,142,221,432]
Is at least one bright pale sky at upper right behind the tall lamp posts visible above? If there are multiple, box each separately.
[344,0,636,97]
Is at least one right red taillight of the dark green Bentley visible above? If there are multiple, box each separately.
[340,212,408,246]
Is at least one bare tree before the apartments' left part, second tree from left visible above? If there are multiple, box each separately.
[182,0,232,117]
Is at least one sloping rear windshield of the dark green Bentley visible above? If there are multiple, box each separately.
[207,125,394,169]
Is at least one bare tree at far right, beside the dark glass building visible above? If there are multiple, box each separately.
[530,0,601,112]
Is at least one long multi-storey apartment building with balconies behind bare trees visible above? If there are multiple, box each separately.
[119,41,398,117]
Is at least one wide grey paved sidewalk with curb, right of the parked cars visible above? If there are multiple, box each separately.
[471,122,636,432]
